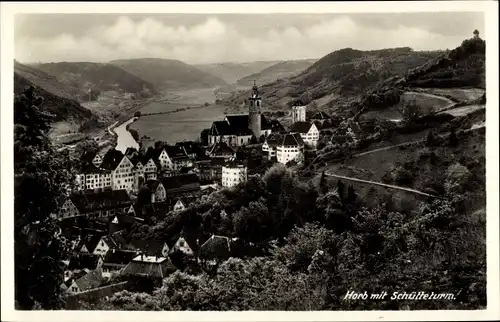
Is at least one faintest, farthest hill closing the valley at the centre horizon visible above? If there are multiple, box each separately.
[193,60,279,84]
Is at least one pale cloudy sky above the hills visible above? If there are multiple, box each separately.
[14,12,484,64]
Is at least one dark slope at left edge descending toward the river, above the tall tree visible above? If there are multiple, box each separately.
[14,71,97,125]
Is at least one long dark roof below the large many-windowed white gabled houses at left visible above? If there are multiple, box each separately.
[71,190,132,214]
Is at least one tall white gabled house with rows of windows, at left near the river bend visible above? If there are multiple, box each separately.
[100,149,134,192]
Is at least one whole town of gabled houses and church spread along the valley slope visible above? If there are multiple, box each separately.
[52,80,346,302]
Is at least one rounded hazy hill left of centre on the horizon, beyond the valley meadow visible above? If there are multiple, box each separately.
[110,58,226,90]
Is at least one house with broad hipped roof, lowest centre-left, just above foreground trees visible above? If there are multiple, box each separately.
[120,254,176,280]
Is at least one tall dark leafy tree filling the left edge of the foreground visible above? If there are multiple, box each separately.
[14,87,74,309]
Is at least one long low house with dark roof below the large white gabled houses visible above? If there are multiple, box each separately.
[57,190,132,219]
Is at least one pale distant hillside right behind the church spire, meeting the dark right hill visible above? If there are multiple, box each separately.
[238,59,317,86]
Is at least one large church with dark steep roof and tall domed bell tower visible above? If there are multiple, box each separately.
[208,82,283,146]
